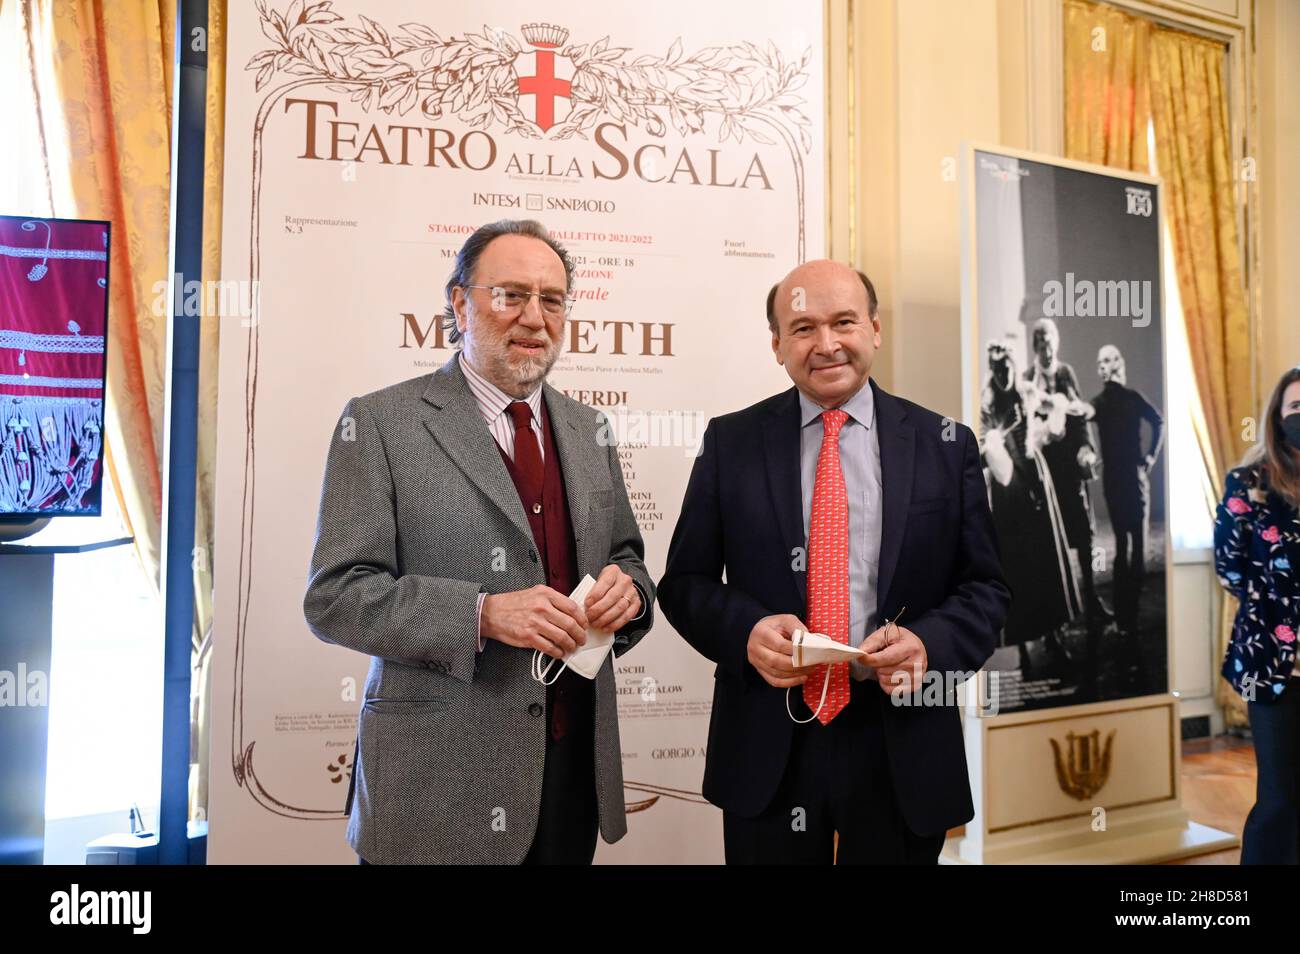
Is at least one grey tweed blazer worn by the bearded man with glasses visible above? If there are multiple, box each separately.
[303,356,654,864]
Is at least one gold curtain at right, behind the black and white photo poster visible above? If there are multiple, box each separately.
[1065,0,1255,724]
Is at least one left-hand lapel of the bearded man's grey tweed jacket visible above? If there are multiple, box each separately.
[423,354,533,541]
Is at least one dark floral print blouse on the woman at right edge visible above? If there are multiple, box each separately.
[1214,467,1300,702]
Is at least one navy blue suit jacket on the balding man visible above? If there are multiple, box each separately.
[659,381,1010,834]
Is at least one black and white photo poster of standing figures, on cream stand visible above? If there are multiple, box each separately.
[963,149,1169,712]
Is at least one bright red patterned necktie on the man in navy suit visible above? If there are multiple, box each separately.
[803,409,849,725]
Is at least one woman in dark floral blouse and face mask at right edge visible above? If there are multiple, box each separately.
[1214,368,1300,864]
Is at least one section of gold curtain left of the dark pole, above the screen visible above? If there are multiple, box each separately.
[31,0,174,585]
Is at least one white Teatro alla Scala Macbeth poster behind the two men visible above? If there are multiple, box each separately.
[208,0,826,863]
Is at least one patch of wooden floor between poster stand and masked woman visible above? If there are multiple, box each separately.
[1171,736,1255,864]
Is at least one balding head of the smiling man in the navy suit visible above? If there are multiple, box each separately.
[767,259,880,408]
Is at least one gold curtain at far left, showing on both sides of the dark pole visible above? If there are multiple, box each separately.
[21,0,226,815]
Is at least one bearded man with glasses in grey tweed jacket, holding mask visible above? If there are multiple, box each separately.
[303,220,654,864]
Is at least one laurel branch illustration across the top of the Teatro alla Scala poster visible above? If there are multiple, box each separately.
[246,0,813,147]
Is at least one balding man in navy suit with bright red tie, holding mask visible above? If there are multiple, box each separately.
[659,261,1010,864]
